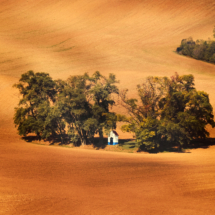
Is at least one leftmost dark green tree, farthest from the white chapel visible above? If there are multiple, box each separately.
[14,71,56,138]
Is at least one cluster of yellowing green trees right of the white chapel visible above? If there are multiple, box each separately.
[118,73,215,150]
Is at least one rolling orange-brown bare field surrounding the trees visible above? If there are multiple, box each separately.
[0,0,215,215]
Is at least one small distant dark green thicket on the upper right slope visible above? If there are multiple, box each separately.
[176,28,215,63]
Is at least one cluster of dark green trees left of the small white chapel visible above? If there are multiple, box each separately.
[14,71,118,144]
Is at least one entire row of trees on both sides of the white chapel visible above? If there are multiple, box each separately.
[14,71,215,150]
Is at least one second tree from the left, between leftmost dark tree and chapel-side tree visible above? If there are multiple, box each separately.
[58,74,96,144]
